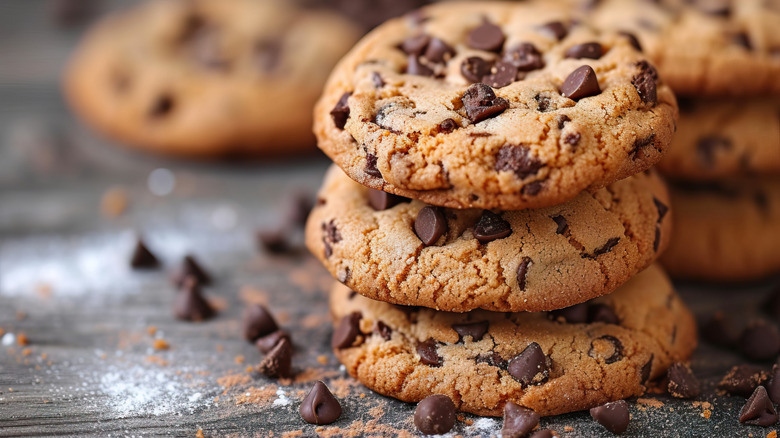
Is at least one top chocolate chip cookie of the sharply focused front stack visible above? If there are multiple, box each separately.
[314,2,677,210]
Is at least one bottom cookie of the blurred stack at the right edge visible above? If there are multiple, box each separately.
[661,178,780,282]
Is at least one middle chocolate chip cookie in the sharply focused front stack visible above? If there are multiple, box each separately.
[306,166,671,312]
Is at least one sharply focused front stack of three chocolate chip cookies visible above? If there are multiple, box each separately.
[306,2,696,422]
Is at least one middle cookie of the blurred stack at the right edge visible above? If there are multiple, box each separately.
[659,98,780,181]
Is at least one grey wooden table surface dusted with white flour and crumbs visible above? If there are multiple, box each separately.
[0,0,772,437]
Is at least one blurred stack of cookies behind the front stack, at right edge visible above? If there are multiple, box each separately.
[580,0,780,282]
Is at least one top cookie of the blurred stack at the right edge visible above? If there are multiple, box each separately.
[588,0,780,96]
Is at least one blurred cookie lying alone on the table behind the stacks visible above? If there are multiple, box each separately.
[65,0,359,157]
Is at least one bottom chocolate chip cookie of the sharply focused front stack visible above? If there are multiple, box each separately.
[330,265,696,416]
